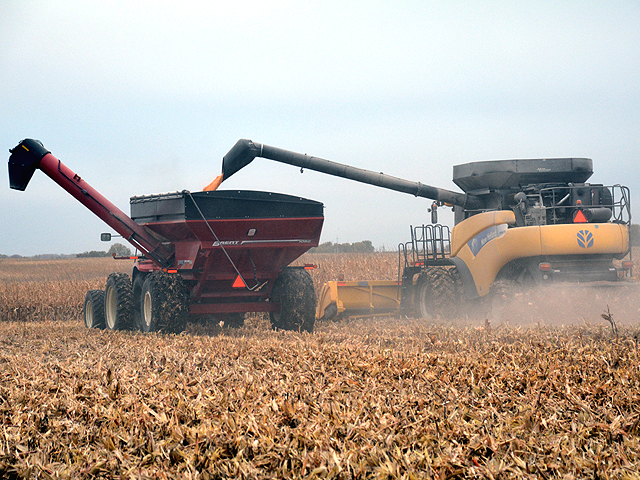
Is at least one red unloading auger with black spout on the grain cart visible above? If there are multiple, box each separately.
[9,138,173,268]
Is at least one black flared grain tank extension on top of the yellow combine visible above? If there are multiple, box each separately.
[453,158,593,193]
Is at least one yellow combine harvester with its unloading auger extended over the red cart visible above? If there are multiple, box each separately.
[211,140,633,318]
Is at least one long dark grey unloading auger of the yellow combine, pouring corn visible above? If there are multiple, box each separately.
[218,139,483,210]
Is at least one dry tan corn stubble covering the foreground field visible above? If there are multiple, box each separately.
[0,257,640,478]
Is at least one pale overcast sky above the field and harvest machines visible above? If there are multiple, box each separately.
[0,0,640,255]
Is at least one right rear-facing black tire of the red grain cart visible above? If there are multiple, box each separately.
[269,268,316,333]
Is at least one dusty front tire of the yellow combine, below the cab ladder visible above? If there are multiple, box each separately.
[416,267,461,319]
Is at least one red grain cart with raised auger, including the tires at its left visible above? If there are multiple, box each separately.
[9,139,324,332]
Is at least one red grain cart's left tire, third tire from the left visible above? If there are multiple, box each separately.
[140,271,189,333]
